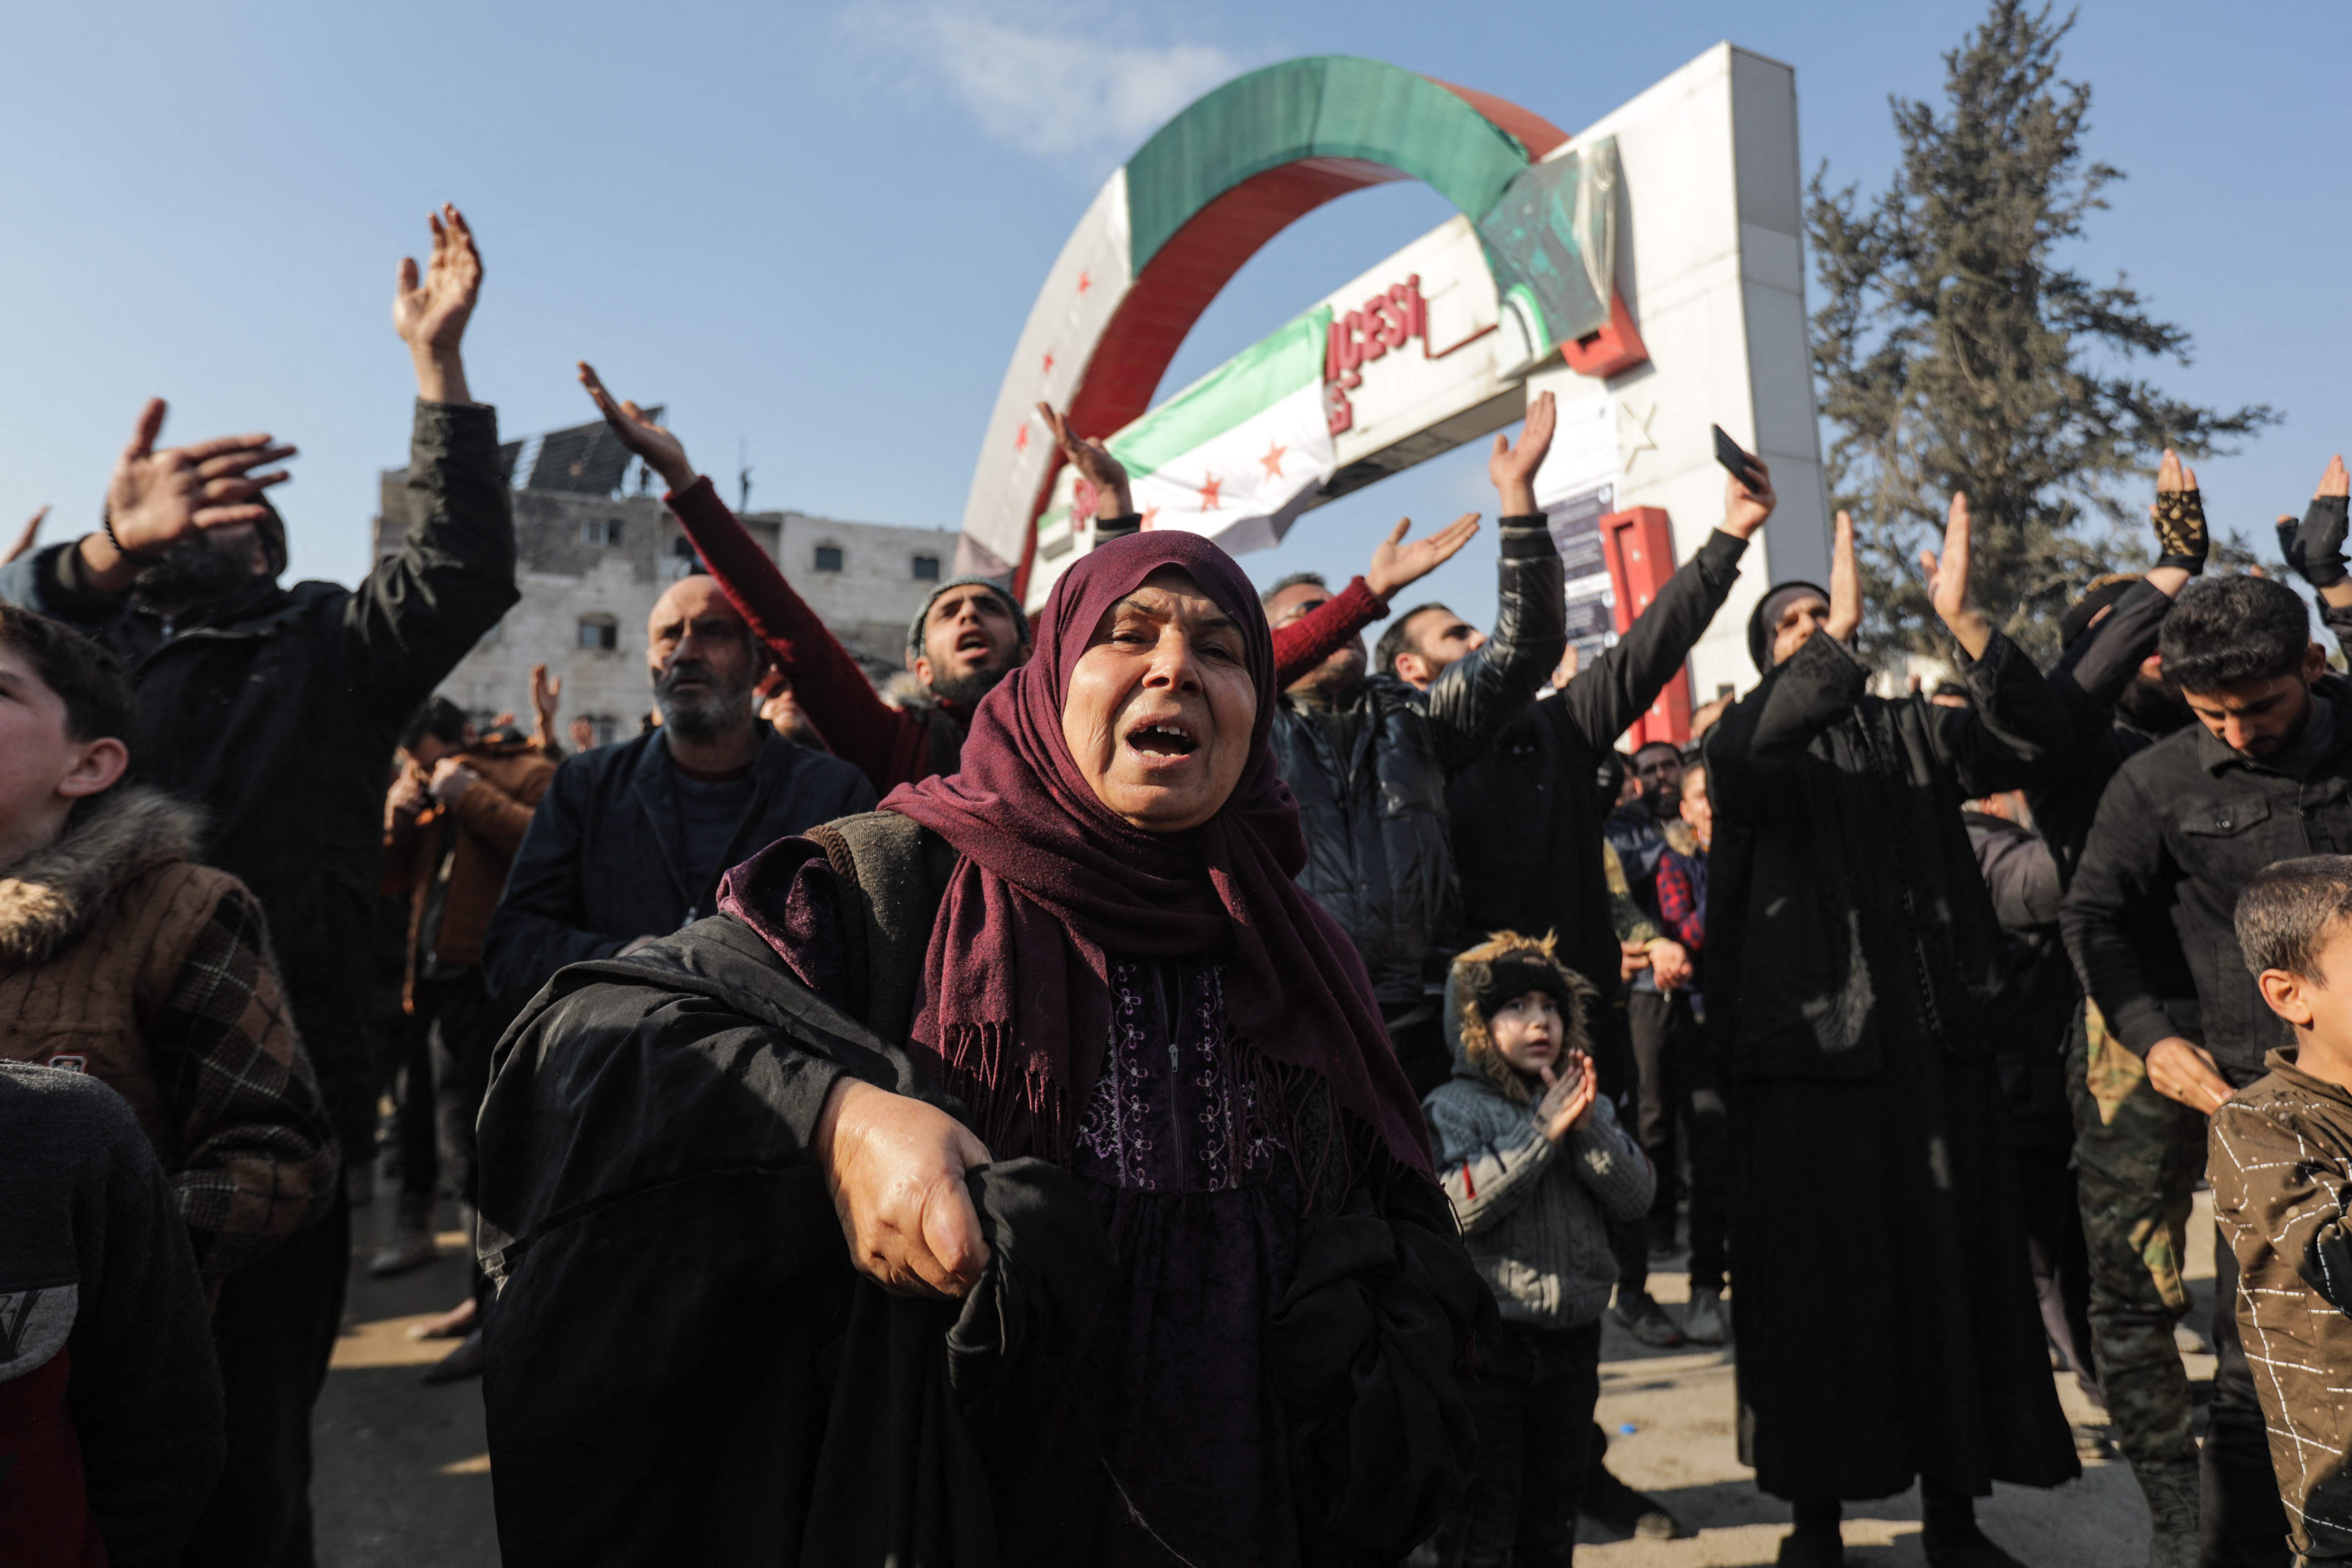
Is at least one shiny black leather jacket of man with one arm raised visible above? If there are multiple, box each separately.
[1275,517,1567,1004]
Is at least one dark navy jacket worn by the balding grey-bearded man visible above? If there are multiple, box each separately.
[482,724,875,997]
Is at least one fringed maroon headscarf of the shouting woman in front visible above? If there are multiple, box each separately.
[882,531,1430,1171]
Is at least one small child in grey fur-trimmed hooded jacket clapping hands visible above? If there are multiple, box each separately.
[1423,931,1656,1568]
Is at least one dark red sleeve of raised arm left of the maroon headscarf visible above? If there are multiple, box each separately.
[663,475,931,795]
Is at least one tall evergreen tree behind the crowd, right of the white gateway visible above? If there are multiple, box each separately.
[1806,0,2277,668]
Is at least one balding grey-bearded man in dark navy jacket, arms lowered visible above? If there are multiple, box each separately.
[482,576,875,997]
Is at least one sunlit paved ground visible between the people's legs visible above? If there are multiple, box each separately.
[315,1194,2213,1568]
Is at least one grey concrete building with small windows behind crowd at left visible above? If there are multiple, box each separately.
[376,409,955,745]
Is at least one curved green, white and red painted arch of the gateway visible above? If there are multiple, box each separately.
[957,56,1580,588]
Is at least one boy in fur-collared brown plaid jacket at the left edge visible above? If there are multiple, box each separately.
[0,604,339,1290]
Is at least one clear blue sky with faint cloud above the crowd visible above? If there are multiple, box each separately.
[0,0,2352,639]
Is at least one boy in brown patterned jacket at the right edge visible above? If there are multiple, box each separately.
[2209,856,2352,1563]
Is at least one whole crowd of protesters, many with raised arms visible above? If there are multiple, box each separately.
[14,209,2352,1568]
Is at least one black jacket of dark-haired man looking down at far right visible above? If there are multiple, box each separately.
[2060,675,2352,1074]
